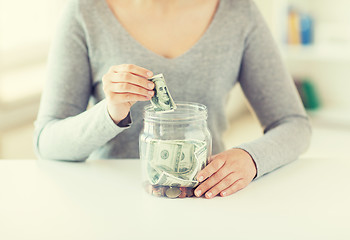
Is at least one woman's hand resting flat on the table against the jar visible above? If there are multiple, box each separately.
[194,149,256,198]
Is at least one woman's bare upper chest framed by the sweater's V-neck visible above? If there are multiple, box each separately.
[104,0,218,59]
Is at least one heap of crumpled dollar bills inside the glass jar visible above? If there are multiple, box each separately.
[143,139,208,187]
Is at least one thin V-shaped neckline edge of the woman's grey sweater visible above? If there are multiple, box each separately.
[100,0,225,61]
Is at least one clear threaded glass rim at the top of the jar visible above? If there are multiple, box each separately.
[144,101,208,123]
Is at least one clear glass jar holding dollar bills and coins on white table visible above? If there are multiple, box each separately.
[139,102,212,198]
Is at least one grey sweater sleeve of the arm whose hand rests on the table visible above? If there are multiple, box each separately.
[237,1,311,178]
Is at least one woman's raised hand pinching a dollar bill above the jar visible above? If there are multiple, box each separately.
[102,64,154,124]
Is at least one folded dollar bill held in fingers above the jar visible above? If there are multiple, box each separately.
[149,74,176,112]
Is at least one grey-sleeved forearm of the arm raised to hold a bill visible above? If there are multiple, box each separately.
[34,100,128,161]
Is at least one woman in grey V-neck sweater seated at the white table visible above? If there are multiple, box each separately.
[35,0,311,198]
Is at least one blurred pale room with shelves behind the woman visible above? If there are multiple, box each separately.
[0,0,350,159]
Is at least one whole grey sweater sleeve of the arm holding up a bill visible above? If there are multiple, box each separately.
[34,0,130,161]
